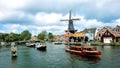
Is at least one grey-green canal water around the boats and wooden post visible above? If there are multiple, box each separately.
[0,43,120,68]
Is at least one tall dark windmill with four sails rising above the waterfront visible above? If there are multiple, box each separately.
[60,11,80,33]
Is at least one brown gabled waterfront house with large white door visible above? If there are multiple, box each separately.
[95,27,120,43]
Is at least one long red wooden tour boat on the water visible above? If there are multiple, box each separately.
[65,46,102,57]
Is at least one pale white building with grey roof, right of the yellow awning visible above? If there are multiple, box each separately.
[81,28,96,41]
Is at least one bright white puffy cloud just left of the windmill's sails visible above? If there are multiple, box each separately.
[34,12,62,25]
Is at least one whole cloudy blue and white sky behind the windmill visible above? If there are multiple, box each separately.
[0,0,120,35]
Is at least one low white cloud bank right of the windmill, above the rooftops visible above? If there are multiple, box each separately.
[74,16,120,31]
